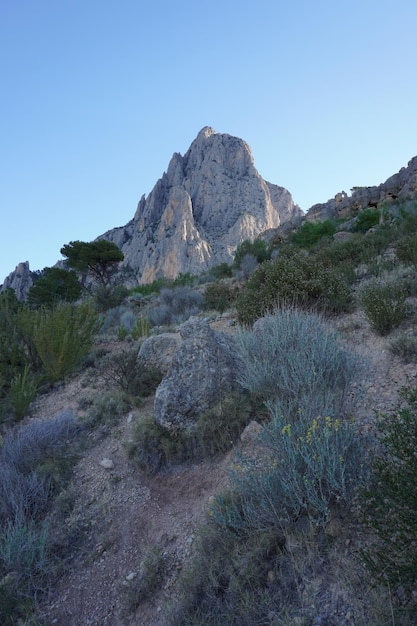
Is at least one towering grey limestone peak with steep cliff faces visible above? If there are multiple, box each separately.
[100,127,302,283]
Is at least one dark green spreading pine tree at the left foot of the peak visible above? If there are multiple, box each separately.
[61,239,124,285]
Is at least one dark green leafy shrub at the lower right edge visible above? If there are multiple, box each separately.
[361,387,417,586]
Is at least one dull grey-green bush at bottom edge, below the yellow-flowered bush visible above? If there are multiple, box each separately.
[168,525,290,626]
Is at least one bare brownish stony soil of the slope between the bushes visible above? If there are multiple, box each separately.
[33,313,417,626]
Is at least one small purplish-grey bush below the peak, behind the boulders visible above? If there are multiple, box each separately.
[149,287,204,326]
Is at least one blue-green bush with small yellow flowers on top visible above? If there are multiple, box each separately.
[211,403,365,537]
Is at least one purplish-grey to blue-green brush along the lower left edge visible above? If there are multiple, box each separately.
[0,411,78,625]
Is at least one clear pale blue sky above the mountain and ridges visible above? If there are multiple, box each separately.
[0,0,417,283]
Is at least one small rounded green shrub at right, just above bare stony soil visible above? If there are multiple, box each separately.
[359,279,407,335]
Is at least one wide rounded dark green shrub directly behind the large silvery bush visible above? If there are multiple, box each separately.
[236,253,352,324]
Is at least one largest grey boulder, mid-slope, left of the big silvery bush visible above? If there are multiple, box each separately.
[154,318,242,433]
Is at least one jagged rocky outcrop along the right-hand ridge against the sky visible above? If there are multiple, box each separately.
[306,156,417,222]
